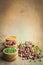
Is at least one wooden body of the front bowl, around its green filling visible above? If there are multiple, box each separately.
[3,48,18,61]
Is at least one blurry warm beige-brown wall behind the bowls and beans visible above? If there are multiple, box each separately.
[0,0,43,47]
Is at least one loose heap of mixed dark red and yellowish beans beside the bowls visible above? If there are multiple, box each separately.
[18,41,41,60]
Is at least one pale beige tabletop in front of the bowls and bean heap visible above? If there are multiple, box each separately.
[0,57,43,65]
